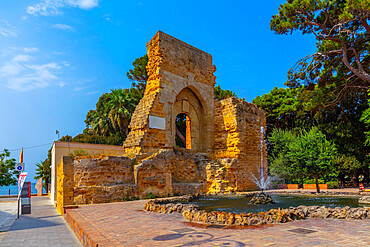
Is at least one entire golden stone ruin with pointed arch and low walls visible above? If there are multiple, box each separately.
[56,31,267,212]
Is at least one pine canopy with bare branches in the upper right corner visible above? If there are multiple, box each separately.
[270,0,370,105]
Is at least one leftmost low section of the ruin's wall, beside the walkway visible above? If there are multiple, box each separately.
[57,156,137,213]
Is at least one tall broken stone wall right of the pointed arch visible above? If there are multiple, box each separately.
[209,97,267,192]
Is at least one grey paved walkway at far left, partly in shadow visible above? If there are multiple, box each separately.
[0,197,81,247]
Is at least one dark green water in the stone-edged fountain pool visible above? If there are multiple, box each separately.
[185,194,361,213]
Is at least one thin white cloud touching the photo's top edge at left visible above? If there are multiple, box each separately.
[26,0,99,16]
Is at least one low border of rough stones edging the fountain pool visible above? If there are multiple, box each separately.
[145,197,370,226]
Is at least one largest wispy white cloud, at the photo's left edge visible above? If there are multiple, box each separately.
[0,47,65,92]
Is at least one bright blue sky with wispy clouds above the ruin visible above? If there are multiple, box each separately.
[0,0,315,183]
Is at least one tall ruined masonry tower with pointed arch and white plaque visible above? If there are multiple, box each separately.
[123,31,216,154]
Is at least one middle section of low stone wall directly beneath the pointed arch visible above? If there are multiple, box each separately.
[135,149,208,197]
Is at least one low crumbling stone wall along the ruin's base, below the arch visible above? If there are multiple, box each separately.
[57,148,272,212]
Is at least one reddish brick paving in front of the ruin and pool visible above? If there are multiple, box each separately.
[67,192,370,247]
